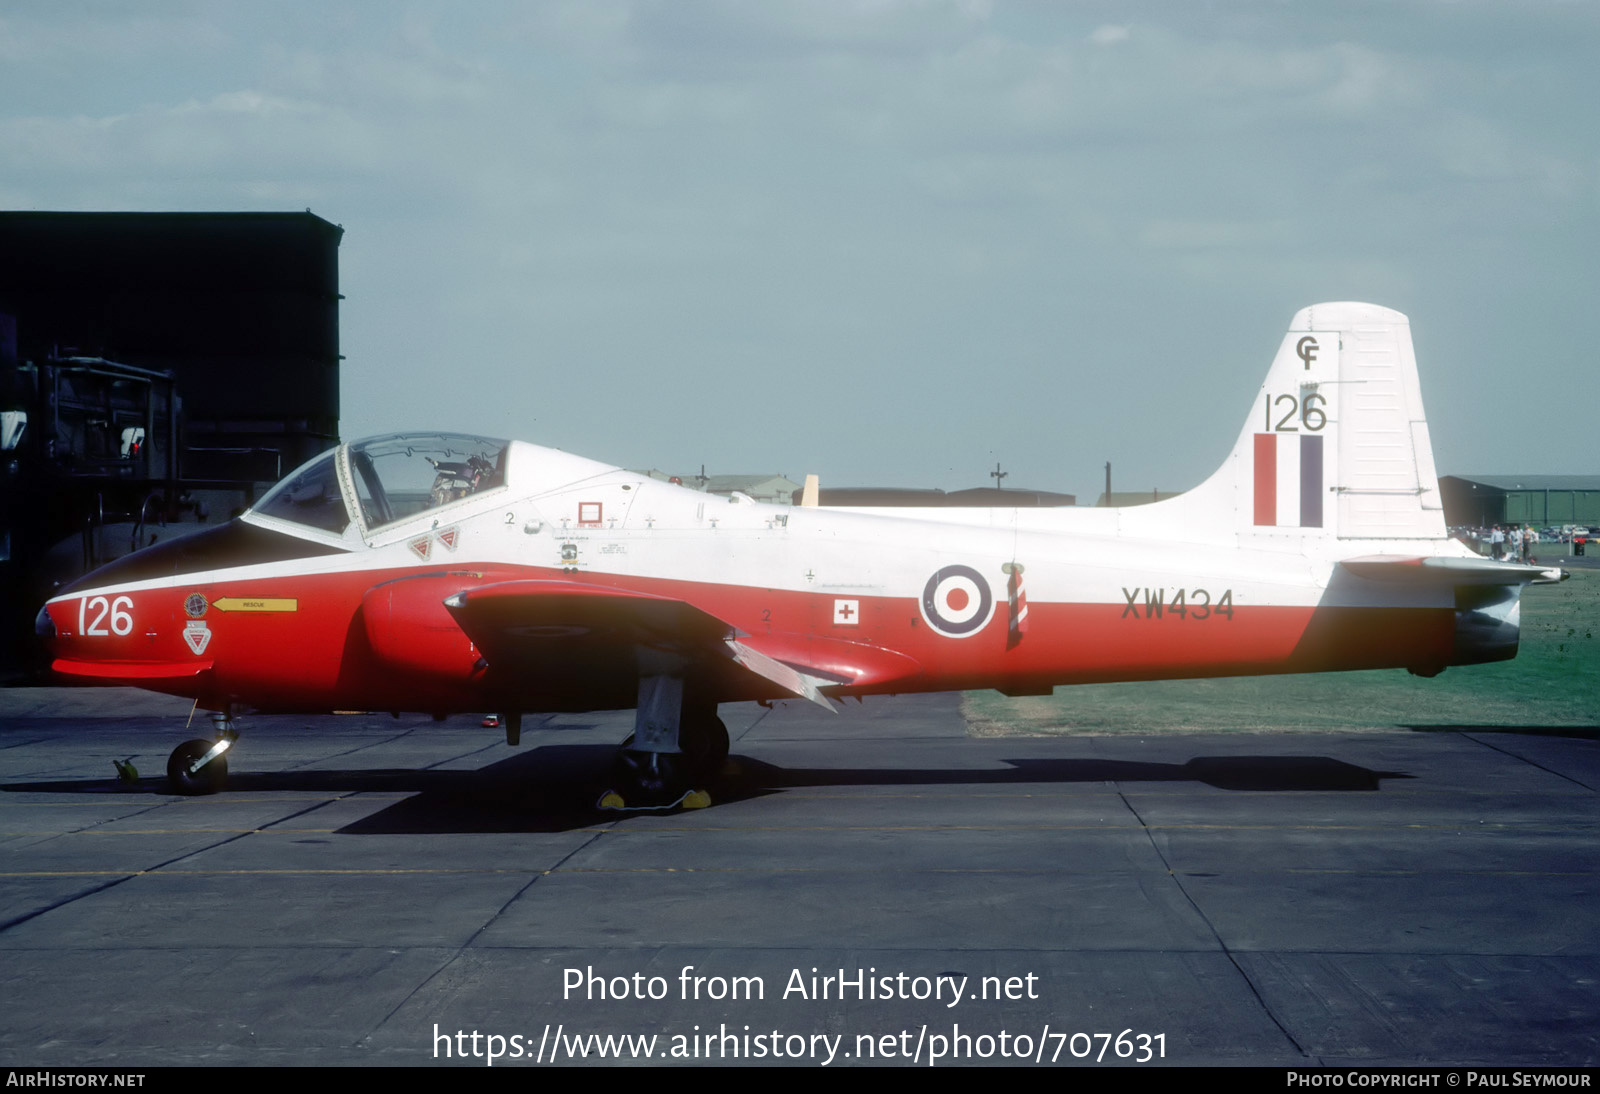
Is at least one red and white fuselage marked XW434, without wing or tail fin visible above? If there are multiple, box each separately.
[46,443,1459,712]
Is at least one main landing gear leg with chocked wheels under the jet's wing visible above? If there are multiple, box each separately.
[598,677,728,809]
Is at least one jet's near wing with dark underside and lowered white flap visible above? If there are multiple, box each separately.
[445,581,834,710]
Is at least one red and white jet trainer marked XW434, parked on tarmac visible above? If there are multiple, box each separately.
[38,304,1565,808]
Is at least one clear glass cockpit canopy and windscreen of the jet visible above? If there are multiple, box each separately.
[251,433,509,536]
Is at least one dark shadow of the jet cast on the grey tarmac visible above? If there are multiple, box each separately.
[9,744,1413,835]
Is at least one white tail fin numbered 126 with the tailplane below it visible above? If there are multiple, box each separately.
[1117,304,1566,675]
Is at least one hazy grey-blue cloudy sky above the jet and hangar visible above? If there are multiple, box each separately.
[0,0,1600,501]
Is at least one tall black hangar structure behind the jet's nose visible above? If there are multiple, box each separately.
[0,210,344,678]
